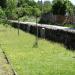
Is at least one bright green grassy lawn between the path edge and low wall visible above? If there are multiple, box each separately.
[0,25,75,75]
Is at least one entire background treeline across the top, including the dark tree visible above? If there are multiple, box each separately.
[0,0,75,21]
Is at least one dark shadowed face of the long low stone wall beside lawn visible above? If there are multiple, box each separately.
[12,22,75,50]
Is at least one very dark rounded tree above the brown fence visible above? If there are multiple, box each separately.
[52,0,66,15]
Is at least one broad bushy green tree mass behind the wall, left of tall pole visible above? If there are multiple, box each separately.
[17,0,41,17]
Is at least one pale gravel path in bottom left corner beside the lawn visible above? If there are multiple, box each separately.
[0,49,13,75]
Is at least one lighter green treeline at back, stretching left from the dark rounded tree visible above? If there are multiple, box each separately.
[0,0,51,19]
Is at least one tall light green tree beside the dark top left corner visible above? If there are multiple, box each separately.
[5,0,17,19]
